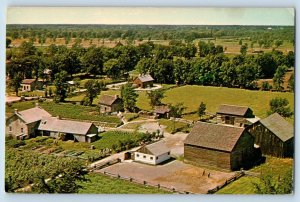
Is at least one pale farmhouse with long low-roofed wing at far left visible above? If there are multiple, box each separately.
[6,105,98,142]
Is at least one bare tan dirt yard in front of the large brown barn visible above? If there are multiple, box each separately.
[95,160,235,194]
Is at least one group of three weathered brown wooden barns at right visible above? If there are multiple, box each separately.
[184,105,294,170]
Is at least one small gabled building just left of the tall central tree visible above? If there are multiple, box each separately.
[99,95,123,113]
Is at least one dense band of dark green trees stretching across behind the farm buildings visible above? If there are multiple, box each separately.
[7,40,295,98]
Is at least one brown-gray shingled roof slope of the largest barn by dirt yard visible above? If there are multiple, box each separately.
[184,122,245,152]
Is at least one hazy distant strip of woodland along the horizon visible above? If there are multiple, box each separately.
[7,25,294,42]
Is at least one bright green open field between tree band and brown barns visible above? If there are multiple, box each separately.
[162,85,294,118]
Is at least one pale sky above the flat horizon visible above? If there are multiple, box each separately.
[7,7,295,25]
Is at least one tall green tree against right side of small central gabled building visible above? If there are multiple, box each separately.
[121,83,138,111]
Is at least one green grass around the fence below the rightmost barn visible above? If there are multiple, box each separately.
[216,156,293,194]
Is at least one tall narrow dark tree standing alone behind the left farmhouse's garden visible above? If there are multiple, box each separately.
[54,71,68,102]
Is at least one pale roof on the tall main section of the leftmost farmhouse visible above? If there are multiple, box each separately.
[15,106,51,124]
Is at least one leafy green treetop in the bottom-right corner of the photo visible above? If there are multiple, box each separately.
[253,168,293,194]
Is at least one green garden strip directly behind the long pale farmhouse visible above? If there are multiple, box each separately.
[6,101,120,124]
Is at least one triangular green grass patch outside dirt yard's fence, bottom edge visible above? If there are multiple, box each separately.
[78,173,170,194]
